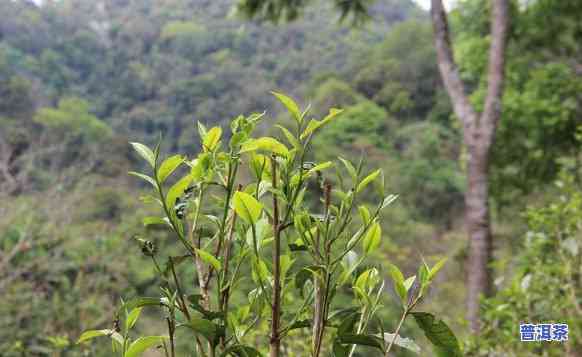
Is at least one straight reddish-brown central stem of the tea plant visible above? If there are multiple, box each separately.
[270,156,281,357]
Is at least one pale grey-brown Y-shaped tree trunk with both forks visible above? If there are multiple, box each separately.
[431,0,509,334]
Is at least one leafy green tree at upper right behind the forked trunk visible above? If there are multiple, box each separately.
[453,0,582,205]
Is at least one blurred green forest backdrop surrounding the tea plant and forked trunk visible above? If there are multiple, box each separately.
[0,0,582,356]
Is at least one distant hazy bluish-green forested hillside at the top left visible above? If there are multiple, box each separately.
[1,0,419,152]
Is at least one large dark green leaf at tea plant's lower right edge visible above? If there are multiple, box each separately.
[411,312,463,357]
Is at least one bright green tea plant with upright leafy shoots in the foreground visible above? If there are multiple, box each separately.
[79,93,460,357]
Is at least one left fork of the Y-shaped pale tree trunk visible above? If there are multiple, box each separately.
[430,0,477,135]
